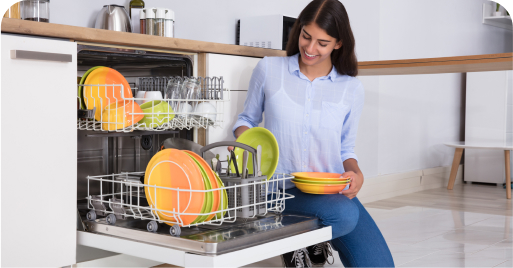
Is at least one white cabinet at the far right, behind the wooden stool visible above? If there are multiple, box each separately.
[464,71,513,184]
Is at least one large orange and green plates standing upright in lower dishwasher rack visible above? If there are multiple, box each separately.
[144,149,228,226]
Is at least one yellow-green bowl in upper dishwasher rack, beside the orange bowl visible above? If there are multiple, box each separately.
[139,100,175,128]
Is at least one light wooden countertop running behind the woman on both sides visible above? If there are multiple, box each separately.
[2,18,513,76]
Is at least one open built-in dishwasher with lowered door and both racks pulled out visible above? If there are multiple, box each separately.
[77,45,331,267]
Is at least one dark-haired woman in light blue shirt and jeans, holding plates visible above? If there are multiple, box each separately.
[233,0,394,267]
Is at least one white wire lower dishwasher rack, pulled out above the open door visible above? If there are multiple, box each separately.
[82,172,294,236]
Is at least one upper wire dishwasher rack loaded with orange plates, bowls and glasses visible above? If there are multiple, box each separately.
[77,77,226,132]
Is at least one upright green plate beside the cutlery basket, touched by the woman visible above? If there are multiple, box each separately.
[230,127,280,180]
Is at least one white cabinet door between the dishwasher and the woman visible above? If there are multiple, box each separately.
[207,54,264,160]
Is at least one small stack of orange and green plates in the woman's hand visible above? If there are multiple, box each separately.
[292,172,351,194]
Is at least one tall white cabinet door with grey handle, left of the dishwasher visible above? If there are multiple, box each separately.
[1,34,77,267]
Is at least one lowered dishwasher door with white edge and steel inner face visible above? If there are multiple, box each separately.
[77,214,331,267]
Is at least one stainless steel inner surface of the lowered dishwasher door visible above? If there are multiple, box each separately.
[83,215,321,255]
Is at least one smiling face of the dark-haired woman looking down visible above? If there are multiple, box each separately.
[299,23,342,66]
